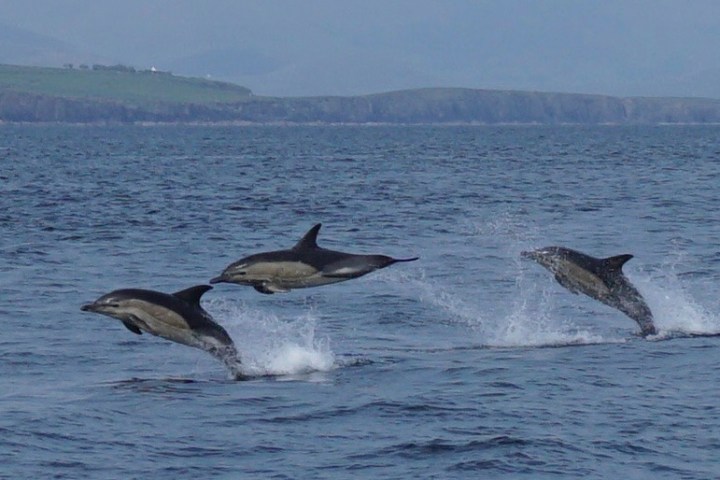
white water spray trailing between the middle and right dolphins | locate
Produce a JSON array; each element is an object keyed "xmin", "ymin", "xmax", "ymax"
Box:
[{"xmin": 380, "ymin": 212, "xmax": 626, "ymax": 347}]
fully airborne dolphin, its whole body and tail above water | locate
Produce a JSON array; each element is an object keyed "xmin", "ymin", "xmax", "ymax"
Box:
[{"xmin": 210, "ymin": 223, "xmax": 419, "ymax": 294}]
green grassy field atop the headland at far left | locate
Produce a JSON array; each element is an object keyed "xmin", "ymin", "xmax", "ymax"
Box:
[{"xmin": 0, "ymin": 65, "xmax": 251, "ymax": 104}]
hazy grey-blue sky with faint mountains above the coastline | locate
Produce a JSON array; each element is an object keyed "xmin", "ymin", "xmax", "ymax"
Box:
[{"xmin": 0, "ymin": 0, "xmax": 720, "ymax": 98}]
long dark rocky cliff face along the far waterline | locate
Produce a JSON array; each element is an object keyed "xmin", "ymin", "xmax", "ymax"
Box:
[{"xmin": 0, "ymin": 88, "xmax": 720, "ymax": 124}]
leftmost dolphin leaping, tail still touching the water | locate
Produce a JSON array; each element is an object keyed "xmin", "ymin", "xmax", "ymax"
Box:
[{"xmin": 80, "ymin": 285, "xmax": 243, "ymax": 379}]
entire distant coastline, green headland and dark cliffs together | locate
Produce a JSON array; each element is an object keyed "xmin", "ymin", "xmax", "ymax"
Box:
[{"xmin": 0, "ymin": 65, "xmax": 720, "ymax": 124}]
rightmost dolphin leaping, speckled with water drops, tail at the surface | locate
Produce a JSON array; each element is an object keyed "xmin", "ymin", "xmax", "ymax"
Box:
[{"xmin": 521, "ymin": 247, "xmax": 657, "ymax": 337}]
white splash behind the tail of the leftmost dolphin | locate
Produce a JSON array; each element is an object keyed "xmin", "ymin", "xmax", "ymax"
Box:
[{"xmin": 207, "ymin": 299, "xmax": 335, "ymax": 377}]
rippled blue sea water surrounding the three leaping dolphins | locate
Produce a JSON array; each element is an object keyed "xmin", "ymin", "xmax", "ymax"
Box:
[{"xmin": 0, "ymin": 125, "xmax": 720, "ymax": 479}]
